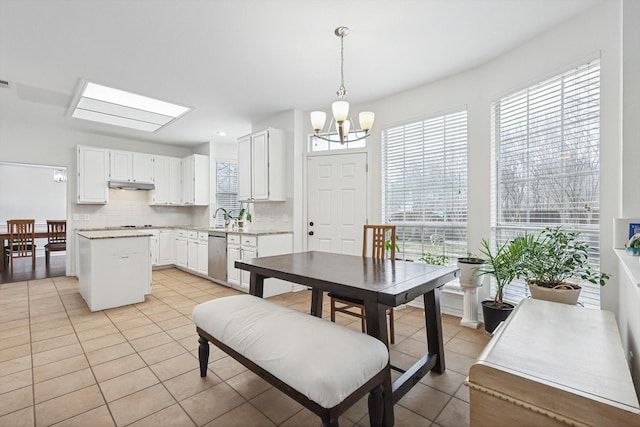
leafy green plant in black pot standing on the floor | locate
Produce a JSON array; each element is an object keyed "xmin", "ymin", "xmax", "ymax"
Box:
[{"xmin": 478, "ymin": 237, "xmax": 523, "ymax": 334}]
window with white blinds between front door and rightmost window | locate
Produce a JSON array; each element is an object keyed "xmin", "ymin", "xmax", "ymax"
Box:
[{"xmin": 382, "ymin": 111, "xmax": 467, "ymax": 263}]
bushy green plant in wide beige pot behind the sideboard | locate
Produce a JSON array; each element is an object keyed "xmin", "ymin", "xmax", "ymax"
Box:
[{"xmin": 521, "ymin": 227, "xmax": 609, "ymax": 304}]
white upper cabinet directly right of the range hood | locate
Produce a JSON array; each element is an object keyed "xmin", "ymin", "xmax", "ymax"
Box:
[{"xmin": 150, "ymin": 156, "xmax": 182, "ymax": 205}]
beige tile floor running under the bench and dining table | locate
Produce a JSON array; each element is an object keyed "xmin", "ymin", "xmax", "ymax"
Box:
[{"xmin": 0, "ymin": 269, "xmax": 488, "ymax": 427}]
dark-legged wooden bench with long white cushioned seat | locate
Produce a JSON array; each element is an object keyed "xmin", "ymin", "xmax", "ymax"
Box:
[{"xmin": 193, "ymin": 295, "xmax": 391, "ymax": 426}]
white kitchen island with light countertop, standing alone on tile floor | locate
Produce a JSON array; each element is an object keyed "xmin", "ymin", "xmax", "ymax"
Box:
[{"xmin": 77, "ymin": 230, "xmax": 152, "ymax": 311}]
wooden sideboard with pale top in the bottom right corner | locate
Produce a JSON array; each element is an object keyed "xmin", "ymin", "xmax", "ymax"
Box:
[{"xmin": 467, "ymin": 299, "xmax": 640, "ymax": 427}]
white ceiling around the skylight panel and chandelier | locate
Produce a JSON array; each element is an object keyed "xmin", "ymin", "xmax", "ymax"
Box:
[{"xmin": 0, "ymin": 0, "xmax": 600, "ymax": 146}]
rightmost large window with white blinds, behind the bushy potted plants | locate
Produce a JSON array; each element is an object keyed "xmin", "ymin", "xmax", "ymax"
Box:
[{"xmin": 492, "ymin": 61, "xmax": 600, "ymax": 307}]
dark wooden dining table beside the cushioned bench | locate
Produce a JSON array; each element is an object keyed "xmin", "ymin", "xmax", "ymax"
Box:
[{"xmin": 235, "ymin": 251, "xmax": 459, "ymax": 426}]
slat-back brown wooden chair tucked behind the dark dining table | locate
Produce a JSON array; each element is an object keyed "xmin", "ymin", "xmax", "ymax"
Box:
[{"xmin": 329, "ymin": 224, "xmax": 396, "ymax": 344}]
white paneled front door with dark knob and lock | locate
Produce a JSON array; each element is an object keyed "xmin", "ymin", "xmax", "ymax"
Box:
[{"xmin": 307, "ymin": 153, "xmax": 367, "ymax": 256}]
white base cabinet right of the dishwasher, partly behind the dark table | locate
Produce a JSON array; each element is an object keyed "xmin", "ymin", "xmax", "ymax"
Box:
[{"xmin": 227, "ymin": 233, "xmax": 293, "ymax": 297}]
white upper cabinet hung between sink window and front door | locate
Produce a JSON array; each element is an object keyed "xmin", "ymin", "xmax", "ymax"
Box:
[{"xmin": 238, "ymin": 128, "xmax": 286, "ymax": 202}]
